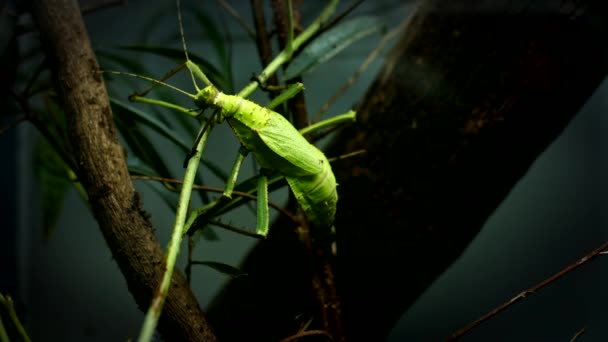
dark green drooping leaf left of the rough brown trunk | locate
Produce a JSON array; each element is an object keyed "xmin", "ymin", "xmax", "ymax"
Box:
[{"xmin": 32, "ymin": 137, "xmax": 72, "ymax": 239}]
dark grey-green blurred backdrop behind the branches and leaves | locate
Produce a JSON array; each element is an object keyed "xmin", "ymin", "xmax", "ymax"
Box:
[{"xmin": 0, "ymin": 1, "xmax": 608, "ymax": 341}]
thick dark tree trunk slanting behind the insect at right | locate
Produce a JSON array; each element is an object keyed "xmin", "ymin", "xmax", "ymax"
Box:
[{"xmin": 209, "ymin": 0, "xmax": 608, "ymax": 341}]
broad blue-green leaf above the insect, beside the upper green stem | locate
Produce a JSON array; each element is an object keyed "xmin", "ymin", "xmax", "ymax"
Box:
[{"xmin": 285, "ymin": 16, "xmax": 384, "ymax": 79}]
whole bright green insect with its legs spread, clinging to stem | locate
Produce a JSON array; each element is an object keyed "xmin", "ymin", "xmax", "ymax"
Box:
[{"xmin": 130, "ymin": 0, "xmax": 355, "ymax": 236}]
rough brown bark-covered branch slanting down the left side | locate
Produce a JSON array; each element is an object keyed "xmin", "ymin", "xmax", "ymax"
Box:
[{"xmin": 32, "ymin": 0, "xmax": 215, "ymax": 341}]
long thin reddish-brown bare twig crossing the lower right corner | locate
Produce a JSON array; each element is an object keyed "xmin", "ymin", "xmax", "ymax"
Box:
[{"xmin": 446, "ymin": 242, "xmax": 608, "ymax": 341}]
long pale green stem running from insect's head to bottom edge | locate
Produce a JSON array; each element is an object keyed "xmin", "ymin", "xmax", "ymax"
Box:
[{"xmin": 138, "ymin": 119, "xmax": 212, "ymax": 342}]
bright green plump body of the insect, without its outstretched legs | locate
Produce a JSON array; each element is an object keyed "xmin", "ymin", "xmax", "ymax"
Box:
[{"xmin": 192, "ymin": 68, "xmax": 338, "ymax": 227}]
